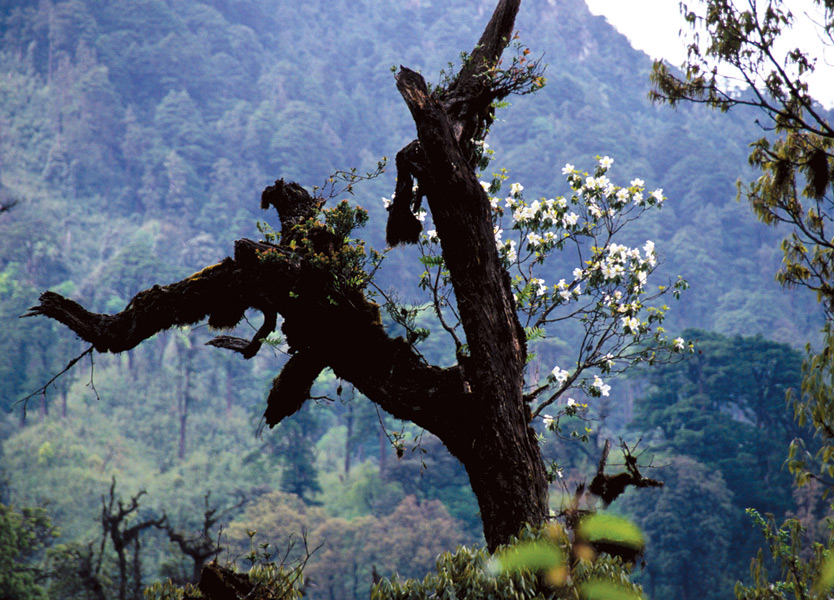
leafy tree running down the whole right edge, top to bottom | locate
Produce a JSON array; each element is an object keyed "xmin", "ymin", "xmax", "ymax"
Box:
[{"xmin": 651, "ymin": 0, "xmax": 834, "ymax": 598}]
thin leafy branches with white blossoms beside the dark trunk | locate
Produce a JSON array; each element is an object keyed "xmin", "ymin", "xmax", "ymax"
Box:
[{"xmin": 412, "ymin": 156, "xmax": 691, "ymax": 418}]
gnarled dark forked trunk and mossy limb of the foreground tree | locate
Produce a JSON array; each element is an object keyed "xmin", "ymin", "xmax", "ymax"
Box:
[{"xmin": 29, "ymin": 0, "xmax": 547, "ymax": 549}]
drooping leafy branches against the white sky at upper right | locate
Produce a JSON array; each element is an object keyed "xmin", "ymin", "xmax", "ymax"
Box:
[{"xmin": 650, "ymin": 0, "xmax": 834, "ymax": 324}]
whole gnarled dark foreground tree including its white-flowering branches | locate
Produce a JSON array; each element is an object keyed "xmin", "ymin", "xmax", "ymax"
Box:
[{"xmin": 30, "ymin": 0, "xmax": 686, "ymax": 549}]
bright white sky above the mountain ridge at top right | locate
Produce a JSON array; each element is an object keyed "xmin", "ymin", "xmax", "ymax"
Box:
[{"xmin": 585, "ymin": 0, "xmax": 834, "ymax": 108}]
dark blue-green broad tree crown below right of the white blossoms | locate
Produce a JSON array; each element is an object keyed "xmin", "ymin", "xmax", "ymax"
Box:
[{"xmin": 631, "ymin": 330, "xmax": 807, "ymax": 515}]
